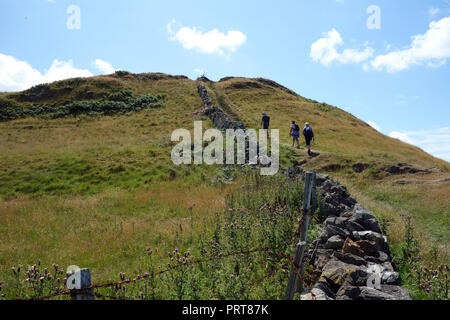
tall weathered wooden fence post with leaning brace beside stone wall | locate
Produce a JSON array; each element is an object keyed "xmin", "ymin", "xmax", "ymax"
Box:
[{"xmin": 284, "ymin": 172, "xmax": 315, "ymax": 300}]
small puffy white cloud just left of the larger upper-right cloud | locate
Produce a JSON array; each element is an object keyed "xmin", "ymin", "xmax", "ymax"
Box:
[{"xmin": 310, "ymin": 29, "xmax": 374, "ymax": 66}]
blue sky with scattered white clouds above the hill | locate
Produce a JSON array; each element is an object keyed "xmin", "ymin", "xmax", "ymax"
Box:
[{"xmin": 0, "ymin": 0, "xmax": 450, "ymax": 161}]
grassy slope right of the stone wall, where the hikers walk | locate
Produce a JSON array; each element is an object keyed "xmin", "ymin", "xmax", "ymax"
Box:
[{"xmin": 210, "ymin": 78, "xmax": 450, "ymax": 253}]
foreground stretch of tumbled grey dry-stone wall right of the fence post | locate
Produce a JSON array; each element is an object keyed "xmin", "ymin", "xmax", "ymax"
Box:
[{"xmin": 288, "ymin": 169, "xmax": 411, "ymax": 300}]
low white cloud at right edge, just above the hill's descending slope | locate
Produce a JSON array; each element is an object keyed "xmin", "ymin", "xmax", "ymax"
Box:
[{"xmin": 389, "ymin": 127, "xmax": 450, "ymax": 161}]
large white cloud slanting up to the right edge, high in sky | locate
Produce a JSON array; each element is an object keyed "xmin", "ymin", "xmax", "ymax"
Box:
[{"xmin": 364, "ymin": 17, "xmax": 450, "ymax": 73}]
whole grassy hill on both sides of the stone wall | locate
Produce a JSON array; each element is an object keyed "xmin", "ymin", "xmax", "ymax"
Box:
[{"xmin": 0, "ymin": 72, "xmax": 450, "ymax": 298}]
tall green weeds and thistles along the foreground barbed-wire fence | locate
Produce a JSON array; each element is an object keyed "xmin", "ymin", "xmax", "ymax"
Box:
[{"xmin": 2, "ymin": 172, "xmax": 310, "ymax": 299}]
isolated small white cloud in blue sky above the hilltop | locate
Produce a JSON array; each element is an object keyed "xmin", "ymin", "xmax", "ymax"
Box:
[{"xmin": 167, "ymin": 20, "xmax": 247, "ymax": 57}]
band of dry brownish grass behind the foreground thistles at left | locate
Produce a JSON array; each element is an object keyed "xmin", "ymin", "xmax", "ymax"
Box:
[{"xmin": 0, "ymin": 183, "xmax": 237, "ymax": 281}]
